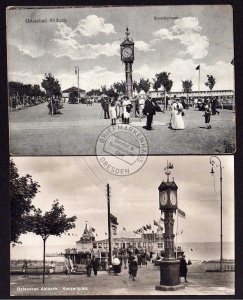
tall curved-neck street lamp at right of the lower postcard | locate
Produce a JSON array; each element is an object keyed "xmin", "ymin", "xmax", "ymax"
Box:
[{"xmin": 209, "ymin": 156, "xmax": 224, "ymax": 272}]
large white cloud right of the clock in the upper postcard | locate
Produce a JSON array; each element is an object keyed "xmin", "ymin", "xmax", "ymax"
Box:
[{"xmin": 153, "ymin": 17, "xmax": 209, "ymax": 59}]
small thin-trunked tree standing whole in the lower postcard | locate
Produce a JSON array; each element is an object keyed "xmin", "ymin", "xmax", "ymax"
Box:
[{"xmin": 29, "ymin": 200, "xmax": 77, "ymax": 283}]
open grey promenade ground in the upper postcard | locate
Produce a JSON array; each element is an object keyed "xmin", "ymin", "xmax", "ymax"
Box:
[{"xmin": 9, "ymin": 103, "xmax": 235, "ymax": 155}]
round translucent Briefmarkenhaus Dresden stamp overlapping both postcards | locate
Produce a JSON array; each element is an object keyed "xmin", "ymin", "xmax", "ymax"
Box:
[{"xmin": 96, "ymin": 124, "xmax": 148, "ymax": 176}]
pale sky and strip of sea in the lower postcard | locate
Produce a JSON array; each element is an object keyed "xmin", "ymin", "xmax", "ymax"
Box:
[{"xmin": 10, "ymin": 156, "xmax": 234, "ymax": 253}]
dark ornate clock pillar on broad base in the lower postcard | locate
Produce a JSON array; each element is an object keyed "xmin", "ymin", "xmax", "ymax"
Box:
[{"xmin": 155, "ymin": 162, "xmax": 185, "ymax": 291}]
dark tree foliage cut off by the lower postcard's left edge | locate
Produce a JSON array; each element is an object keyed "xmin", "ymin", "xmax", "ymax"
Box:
[{"xmin": 9, "ymin": 160, "xmax": 40, "ymax": 246}]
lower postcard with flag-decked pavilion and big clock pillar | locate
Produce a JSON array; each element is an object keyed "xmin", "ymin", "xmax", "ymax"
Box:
[{"xmin": 10, "ymin": 155, "xmax": 235, "ymax": 297}]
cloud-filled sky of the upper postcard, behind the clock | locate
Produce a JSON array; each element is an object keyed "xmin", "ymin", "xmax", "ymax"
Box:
[{"xmin": 7, "ymin": 5, "xmax": 234, "ymax": 92}]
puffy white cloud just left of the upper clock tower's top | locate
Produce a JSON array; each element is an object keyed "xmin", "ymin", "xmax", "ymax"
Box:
[{"xmin": 75, "ymin": 15, "xmax": 116, "ymax": 37}]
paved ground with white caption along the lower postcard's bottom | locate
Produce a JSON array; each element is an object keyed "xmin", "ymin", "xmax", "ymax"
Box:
[{"xmin": 11, "ymin": 262, "xmax": 234, "ymax": 296}]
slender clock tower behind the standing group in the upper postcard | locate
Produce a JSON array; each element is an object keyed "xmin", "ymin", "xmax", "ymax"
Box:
[{"xmin": 120, "ymin": 28, "xmax": 134, "ymax": 100}]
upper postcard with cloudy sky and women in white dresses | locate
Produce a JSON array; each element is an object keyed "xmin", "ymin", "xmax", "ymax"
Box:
[{"xmin": 6, "ymin": 5, "xmax": 237, "ymax": 156}]
